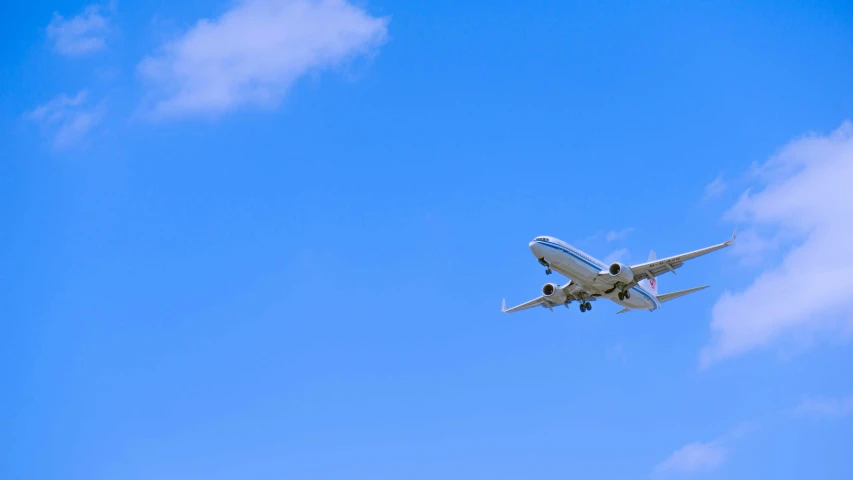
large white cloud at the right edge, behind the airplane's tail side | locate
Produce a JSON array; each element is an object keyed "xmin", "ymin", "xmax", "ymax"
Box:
[{"xmin": 700, "ymin": 122, "xmax": 853, "ymax": 366}]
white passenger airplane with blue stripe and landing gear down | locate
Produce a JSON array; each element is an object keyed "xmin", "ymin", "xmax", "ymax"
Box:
[{"xmin": 501, "ymin": 229, "xmax": 737, "ymax": 313}]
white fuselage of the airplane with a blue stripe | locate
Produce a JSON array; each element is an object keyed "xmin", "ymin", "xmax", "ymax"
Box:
[{"xmin": 530, "ymin": 237, "xmax": 660, "ymax": 311}]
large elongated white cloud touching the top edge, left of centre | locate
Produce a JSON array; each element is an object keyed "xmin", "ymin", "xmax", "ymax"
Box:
[{"xmin": 139, "ymin": 0, "xmax": 389, "ymax": 116}]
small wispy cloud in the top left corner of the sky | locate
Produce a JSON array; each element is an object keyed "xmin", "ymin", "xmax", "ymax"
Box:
[{"xmin": 47, "ymin": 5, "xmax": 109, "ymax": 56}]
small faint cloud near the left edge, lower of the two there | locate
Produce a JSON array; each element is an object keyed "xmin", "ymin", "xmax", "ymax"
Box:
[{"xmin": 25, "ymin": 90, "xmax": 102, "ymax": 149}]
